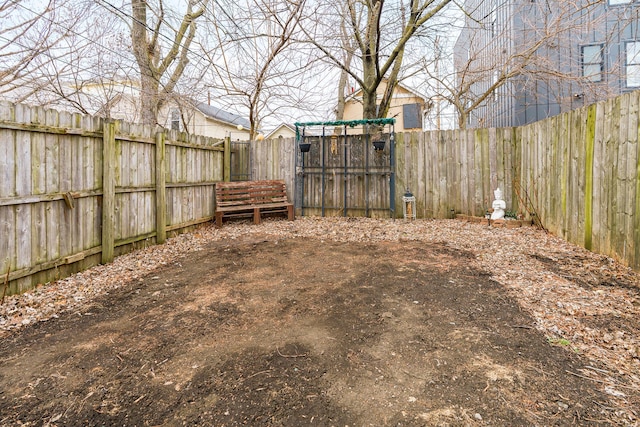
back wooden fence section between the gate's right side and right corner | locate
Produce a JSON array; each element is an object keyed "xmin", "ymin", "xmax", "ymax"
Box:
[{"xmin": 396, "ymin": 128, "xmax": 518, "ymax": 218}]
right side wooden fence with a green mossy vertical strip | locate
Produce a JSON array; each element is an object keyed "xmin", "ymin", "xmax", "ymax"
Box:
[{"xmin": 520, "ymin": 92, "xmax": 640, "ymax": 269}]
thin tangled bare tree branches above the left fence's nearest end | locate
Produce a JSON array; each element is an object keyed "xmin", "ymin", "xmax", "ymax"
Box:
[{"xmin": 0, "ymin": 0, "xmax": 146, "ymax": 120}]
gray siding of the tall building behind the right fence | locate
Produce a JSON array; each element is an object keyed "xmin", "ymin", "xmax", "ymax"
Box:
[{"xmin": 454, "ymin": 0, "xmax": 640, "ymax": 128}]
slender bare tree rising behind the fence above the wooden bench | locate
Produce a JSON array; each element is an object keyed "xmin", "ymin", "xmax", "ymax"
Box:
[{"xmin": 203, "ymin": 0, "xmax": 313, "ymax": 139}]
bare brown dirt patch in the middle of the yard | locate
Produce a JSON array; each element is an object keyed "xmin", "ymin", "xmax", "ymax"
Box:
[{"xmin": 0, "ymin": 222, "xmax": 640, "ymax": 427}]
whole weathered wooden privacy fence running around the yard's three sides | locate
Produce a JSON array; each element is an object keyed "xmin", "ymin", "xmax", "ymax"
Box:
[{"xmin": 0, "ymin": 88, "xmax": 640, "ymax": 293}]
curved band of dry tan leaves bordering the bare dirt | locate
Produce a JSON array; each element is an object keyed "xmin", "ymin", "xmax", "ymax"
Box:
[{"xmin": 0, "ymin": 217, "xmax": 640, "ymax": 422}]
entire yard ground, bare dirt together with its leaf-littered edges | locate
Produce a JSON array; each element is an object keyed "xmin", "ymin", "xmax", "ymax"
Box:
[{"xmin": 0, "ymin": 218, "xmax": 640, "ymax": 427}]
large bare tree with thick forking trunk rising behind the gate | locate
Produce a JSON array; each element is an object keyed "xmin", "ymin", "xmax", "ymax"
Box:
[{"xmin": 305, "ymin": 0, "xmax": 451, "ymax": 118}]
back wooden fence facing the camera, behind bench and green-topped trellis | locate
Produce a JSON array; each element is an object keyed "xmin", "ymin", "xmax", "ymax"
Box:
[{"xmin": 251, "ymin": 128, "xmax": 520, "ymax": 218}]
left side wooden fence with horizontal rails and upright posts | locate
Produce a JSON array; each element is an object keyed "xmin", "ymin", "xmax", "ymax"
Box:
[{"xmin": 0, "ymin": 103, "xmax": 231, "ymax": 293}]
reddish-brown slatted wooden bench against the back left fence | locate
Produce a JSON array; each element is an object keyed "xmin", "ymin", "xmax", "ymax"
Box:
[{"xmin": 215, "ymin": 180, "xmax": 294, "ymax": 227}]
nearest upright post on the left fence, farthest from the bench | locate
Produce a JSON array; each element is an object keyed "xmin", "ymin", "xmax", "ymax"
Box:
[{"xmin": 102, "ymin": 120, "xmax": 116, "ymax": 264}]
